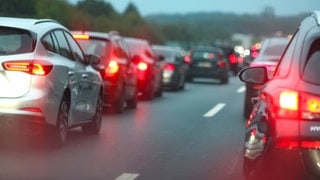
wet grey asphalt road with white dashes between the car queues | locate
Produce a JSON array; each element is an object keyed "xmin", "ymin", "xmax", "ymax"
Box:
[{"xmin": 0, "ymin": 77, "xmax": 249, "ymax": 180}]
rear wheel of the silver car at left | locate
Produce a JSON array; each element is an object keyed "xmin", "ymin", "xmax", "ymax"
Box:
[{"xmin": 53, "ymin": 95, "xmax": 70, "ymax": 148}]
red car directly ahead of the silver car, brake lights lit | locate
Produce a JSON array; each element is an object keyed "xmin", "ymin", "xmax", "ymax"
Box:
[{"xmin": 72, "ymin": 31, "xmax": 138, "ymax": 113}]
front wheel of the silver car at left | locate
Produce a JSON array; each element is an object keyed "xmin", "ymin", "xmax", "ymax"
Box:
[{"xmin": 81, "ymin": 93, "xmax": 103, "ymax": 134}]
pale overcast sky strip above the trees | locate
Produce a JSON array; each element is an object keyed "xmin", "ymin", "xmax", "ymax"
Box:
[{"xmin": 69, "ymin": 0, "xmax": 320, "ymax": 16}]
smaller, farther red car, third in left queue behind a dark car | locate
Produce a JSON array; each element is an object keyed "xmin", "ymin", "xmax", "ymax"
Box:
[{"xmin": 125, "ymin": 37, "xmax": 163, "ymax": 100}]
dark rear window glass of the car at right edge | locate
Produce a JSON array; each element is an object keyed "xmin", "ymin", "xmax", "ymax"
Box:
[{"xmin": 302, "ymin": 39, "xmax": 320, "ymax": 84}]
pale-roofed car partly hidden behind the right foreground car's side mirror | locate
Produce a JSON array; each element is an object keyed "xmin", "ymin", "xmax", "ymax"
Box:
[{"xmin": 243, "ymin": 37, "xmax": 290, "ymax": 118}]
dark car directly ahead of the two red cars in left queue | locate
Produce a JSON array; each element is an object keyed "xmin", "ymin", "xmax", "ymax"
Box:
[{"xmin": 152, "ymin": 45, "xmax": 188, "ymax": 90}]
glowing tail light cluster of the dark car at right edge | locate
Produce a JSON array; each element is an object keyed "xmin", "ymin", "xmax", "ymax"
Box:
[{"xmin": 274, "ymin": 90, "xmax": 320, "ymax": 120}]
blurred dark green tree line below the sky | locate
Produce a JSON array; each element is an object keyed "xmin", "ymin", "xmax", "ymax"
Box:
[{"xmin": 0, "ymin": 0, "xmax": 306, "ymax": 47}]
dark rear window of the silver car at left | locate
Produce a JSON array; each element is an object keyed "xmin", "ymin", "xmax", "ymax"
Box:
[{"xmin": 0, "ymin": 27, "xmax": 33, "ymax": 55}]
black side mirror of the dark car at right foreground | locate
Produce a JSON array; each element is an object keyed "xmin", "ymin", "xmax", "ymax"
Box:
[{"xmin": 239, "ymin": 67, "xmax": 269, "ymax": 85}]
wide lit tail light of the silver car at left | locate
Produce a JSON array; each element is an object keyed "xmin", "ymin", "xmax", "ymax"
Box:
[{"xmin": 2, "ymin": 60, "xmax": 53, "ymax": 76}]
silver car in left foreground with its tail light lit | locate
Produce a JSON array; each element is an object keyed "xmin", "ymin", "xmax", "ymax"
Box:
[{"xmin": 0, "ymin": 17, "xmax": 103, "ymax": 147}]
